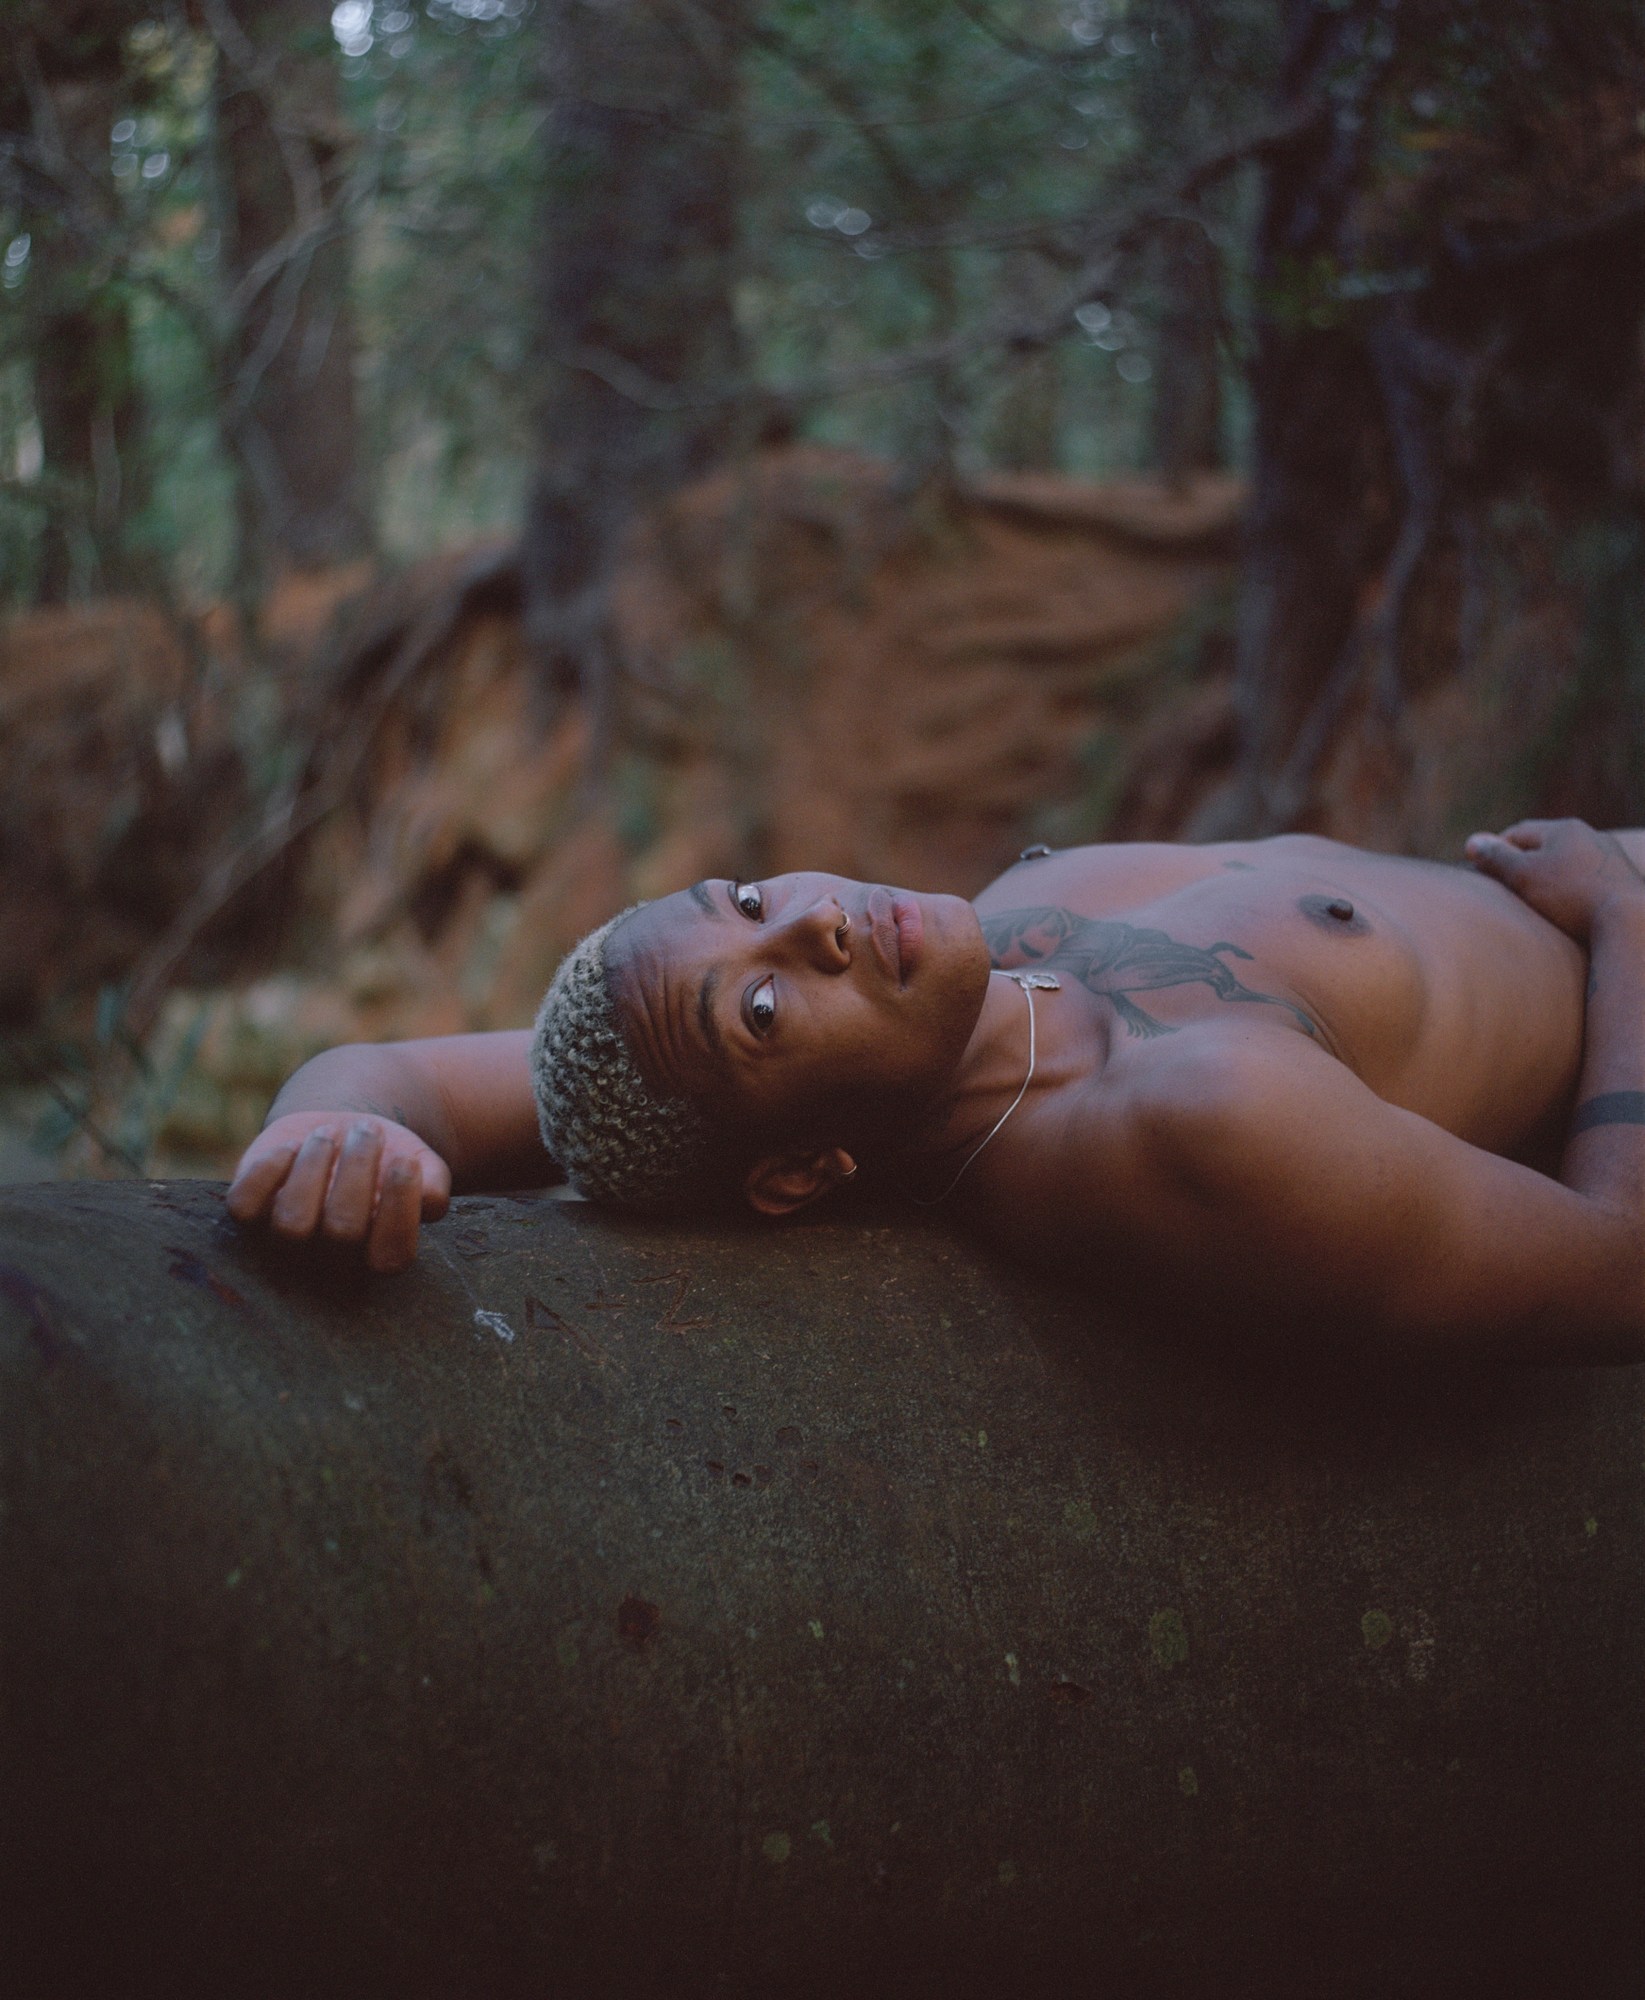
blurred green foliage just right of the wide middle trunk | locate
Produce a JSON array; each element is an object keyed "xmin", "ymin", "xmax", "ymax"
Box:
[{"xmin": 742, "ymin": 0, "xmax": 1273, "ymax": 472}]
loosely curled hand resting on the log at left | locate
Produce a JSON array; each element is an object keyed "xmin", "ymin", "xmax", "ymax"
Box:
[{"xmin": 228, "ymin": 1112, "xmax": 450, "ymax": 1270}]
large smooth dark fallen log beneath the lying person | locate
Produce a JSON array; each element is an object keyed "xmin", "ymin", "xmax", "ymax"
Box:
[{"xmin": 0, "ymin": 1184, "xmax": 1645, "ymax": 2000}]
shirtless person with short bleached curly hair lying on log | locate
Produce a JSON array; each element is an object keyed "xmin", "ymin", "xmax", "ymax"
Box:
[{"xmin": 228, "ymin": 820, "xmax": 1645, "ymax": 1362}]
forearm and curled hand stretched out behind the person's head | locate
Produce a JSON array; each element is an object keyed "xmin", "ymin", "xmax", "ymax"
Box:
[{"xmin": 228, "ymin": 1030, "xmax": 558, "ymax": 1270}]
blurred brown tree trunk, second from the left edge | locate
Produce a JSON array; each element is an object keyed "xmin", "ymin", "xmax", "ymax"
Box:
[{"xmin": 202, "ymin": 0, "xmax": 370, "ymax": 568}]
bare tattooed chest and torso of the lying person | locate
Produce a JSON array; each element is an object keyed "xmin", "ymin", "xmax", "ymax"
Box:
[{"xmin": 977, "ymin": 836, "xmax": 1583, "ymax": 1150}]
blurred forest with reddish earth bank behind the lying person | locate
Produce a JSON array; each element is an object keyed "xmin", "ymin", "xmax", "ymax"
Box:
[{"xmin": 0, "ymin": 0, "xmax": 1645, "ymax": 1178}]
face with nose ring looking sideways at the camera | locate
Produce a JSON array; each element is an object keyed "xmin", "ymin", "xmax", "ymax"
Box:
[{"xmin": 606, "ymin": 874, "xmax": 989, "ymax": 1142}]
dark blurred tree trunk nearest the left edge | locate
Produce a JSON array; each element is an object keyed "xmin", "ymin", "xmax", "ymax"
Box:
[{"xmin": 4, "ymin": 4, "xmax": 146, "ymax": 604}]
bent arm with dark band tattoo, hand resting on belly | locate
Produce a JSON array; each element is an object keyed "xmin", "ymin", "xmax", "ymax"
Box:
[{"xmin": 996, "ymin": 826, "xmax": 1645, "ymax": 1362}]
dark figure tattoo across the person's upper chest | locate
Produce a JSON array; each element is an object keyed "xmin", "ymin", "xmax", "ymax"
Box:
[{"xmin": 983, "ymin": 904, "xmax": 1319, "ymax": 1038}]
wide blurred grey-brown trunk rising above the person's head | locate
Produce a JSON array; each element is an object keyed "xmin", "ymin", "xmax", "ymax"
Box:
[{"xmin": 524, "ymin": 0, "xmax": 744, "ymax": 740}]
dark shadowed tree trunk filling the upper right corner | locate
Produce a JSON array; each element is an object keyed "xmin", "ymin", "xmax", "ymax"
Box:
[{"xmin": 1232, "ymin": 0, "xmax": 1645, "ymax": 838}]
